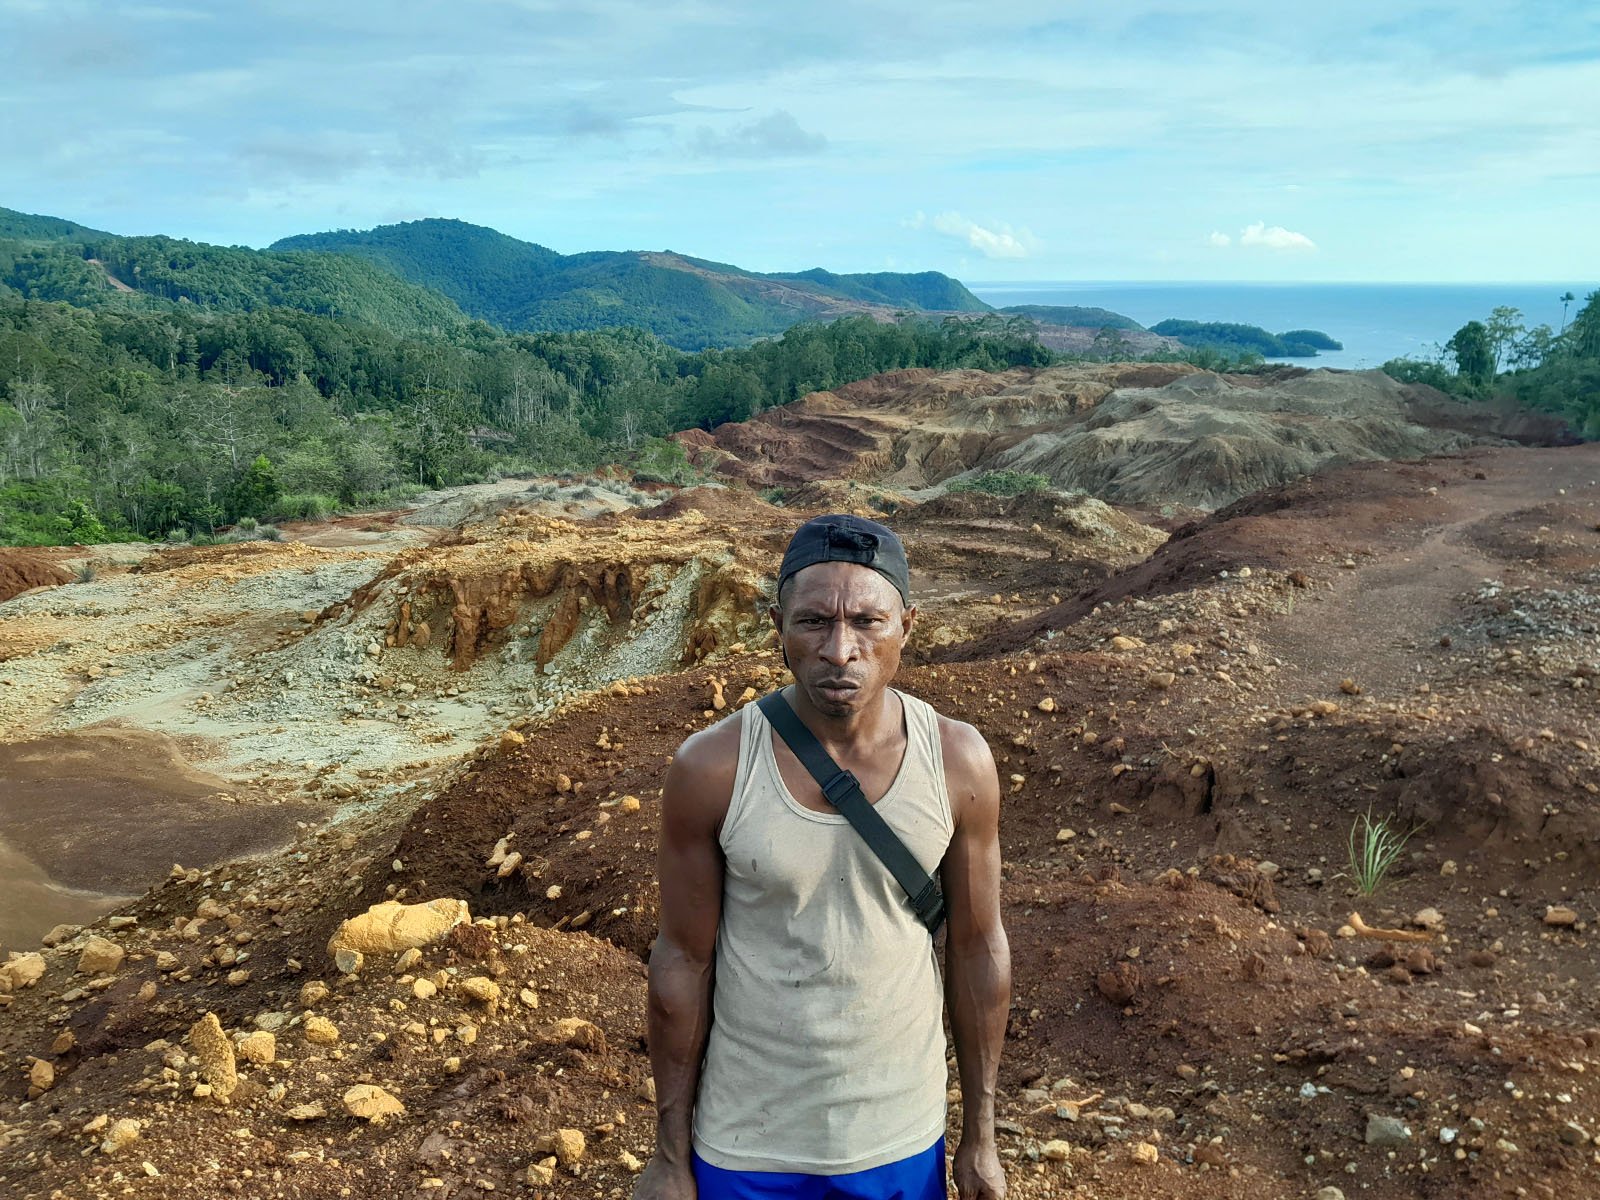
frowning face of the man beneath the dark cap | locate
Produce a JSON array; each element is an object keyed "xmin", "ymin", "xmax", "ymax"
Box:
[{"xmin": 771, "ymin": 563, "xmax": 917, "ymax": 717}]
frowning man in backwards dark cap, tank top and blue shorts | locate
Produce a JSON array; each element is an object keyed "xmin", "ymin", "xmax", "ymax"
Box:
[{"xmin": 634, "ymin": 515, "xmax": 1011, "ymax": 1200}]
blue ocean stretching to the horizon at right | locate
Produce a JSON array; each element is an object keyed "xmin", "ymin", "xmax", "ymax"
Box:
[{"xmin": 966, "ymin": 282, "xmax": 1600, "ymax": 370}]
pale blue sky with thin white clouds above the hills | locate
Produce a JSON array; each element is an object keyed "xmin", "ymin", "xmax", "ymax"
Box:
[{"xmin": 0, "ymin": 0, "xmax": 1600, "ymax": 282}]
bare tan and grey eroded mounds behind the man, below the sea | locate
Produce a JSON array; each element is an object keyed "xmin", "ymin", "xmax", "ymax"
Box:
[{"xmin": 677, "ymin": 363, "xmax": 1497, "ymax": 509}]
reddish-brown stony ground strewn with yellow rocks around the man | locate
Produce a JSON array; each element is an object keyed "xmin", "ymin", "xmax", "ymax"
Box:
[{"xmin": 0, "ymin": 435, "xmax": 1600, "ymax": 1200}]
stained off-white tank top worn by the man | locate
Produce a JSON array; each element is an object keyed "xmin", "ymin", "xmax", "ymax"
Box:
[{"xmin": 694, "ymin": 693, "xmax": 954, "ymax": 1174}]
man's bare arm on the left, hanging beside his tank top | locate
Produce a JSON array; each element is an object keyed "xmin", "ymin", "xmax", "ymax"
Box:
[{"xmin": 634, "ymin": 722, "xmax": 739, "ymax": 1200}]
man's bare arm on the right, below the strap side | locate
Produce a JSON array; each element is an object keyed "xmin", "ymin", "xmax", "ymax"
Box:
[{"xmin": 941, "ymin": 720, "xmax": 1011, "ymax": 1200}]
